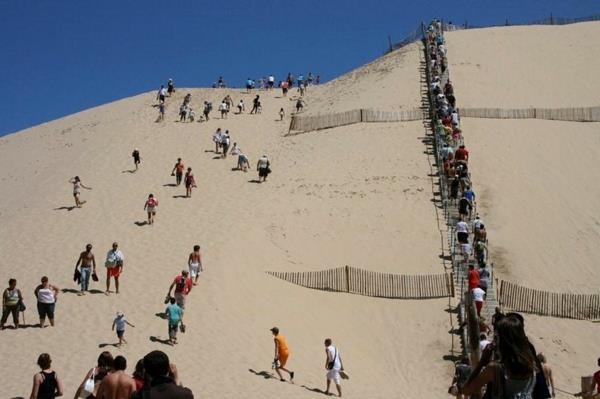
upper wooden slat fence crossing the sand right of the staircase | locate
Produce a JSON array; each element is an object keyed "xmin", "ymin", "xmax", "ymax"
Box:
[{"xmin": 459, "ymin": 107, "xmax": 600, "ymax": 122}]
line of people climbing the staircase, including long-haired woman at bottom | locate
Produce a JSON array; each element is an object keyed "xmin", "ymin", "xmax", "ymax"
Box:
[{"xmin": 425, "ymin": 20, "xmax": 600, "ymax": 399}]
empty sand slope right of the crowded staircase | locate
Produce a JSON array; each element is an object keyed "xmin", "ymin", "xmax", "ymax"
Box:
[{"xmin": 446, "ymin": 22, "xmax": 600, "ymax": 392}]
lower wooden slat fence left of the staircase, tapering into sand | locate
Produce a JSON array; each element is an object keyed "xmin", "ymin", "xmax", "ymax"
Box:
[{"xmin": 267, "ymin": 266, "xmax": 454, "ymax": 299}]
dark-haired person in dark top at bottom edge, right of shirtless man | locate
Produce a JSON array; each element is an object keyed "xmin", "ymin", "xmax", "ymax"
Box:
[{"xmin": 132, "ymin": 351, "xmax": 194, "ymax": 399}]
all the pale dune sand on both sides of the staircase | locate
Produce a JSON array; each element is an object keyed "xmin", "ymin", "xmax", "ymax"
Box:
[{"xmin": 0, "ymin": 19, "xmax": 600, "ymax": 398}]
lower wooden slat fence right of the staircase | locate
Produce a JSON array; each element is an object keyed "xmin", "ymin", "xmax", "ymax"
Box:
[{"xmin": 499, "ymin": 281, "xmax": 600, "ymax": 320}]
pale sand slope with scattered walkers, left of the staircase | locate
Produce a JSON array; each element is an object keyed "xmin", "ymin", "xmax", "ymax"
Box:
[{"xmin": 0, "ymin": 40, "xmax": 452, "ymax": 398}]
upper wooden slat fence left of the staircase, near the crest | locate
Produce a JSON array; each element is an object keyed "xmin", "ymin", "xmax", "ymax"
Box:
[{"xmin": 286, "ymin": 108, "xmax": 423, "ymax": 136}]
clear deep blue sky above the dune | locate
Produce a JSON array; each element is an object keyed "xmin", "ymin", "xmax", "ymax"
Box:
[{"xmin": 0, "ymin": 0, "xmax": 600, "ymax": 136}]
